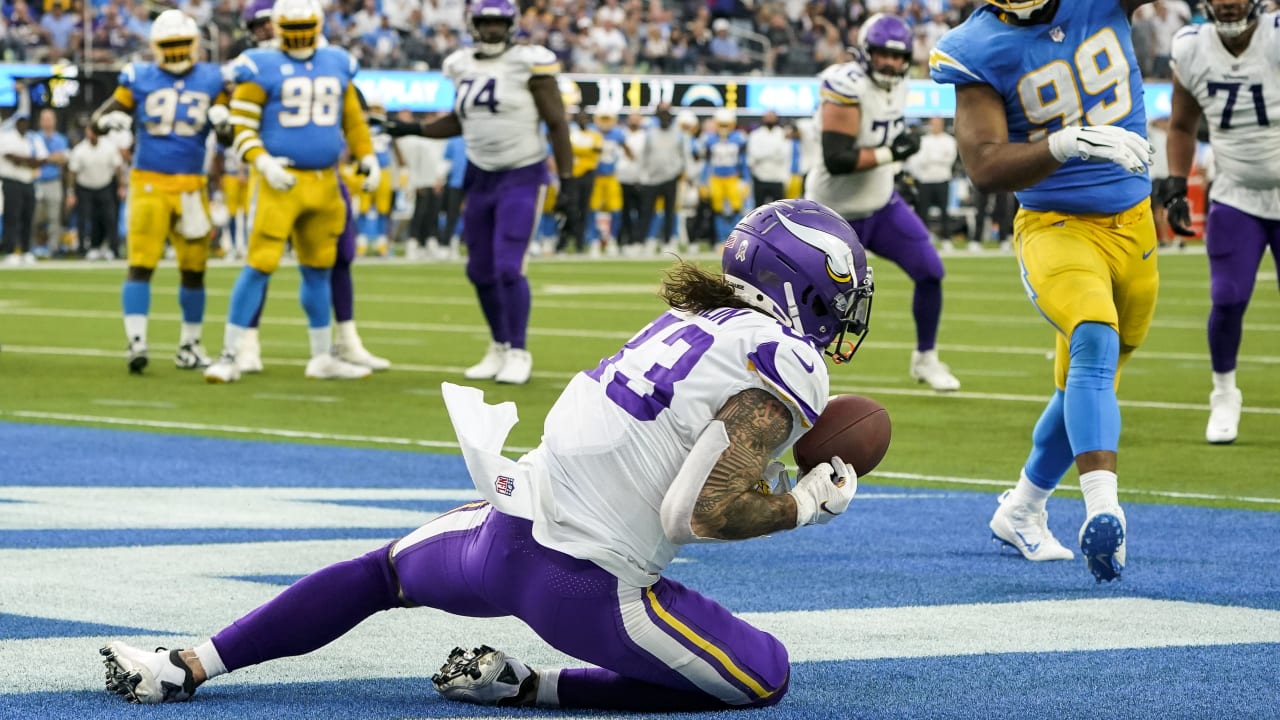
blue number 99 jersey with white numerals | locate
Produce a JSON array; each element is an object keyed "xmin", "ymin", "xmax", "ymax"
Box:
[{"xmin": 929, "ymin": 0, "xmax": 1151, "ymax": 214}]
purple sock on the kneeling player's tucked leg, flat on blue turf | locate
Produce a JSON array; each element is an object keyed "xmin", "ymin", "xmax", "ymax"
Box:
[{"xmin": 556, "ymin": 667, "xmax": 790, "ymax": 712}]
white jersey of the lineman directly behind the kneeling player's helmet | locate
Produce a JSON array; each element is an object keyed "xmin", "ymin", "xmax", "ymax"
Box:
[{"xmin": 804, "ymin": 63, "xmax": 906, "ymax": 219}]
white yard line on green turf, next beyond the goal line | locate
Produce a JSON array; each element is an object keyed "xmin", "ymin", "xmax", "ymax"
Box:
[{"xmin": 4, "ymin": 343, "xmax": 1280, "ymax": 415}]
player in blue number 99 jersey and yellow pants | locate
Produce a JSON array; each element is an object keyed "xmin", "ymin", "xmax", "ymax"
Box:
[{"xmin": 929, "ymin": 0, "xmax": 1160, "ymax": 582}]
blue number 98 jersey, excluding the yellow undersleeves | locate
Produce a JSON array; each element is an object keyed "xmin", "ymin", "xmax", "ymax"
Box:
[{"xmin": 232, "ymin": 46, "xmax": 360, "ymax": 170}]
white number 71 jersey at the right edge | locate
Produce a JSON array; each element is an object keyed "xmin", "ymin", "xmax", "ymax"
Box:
[{"xmin": 1172, "ymin": 13, "xmax": 1280, "ymax": 219}]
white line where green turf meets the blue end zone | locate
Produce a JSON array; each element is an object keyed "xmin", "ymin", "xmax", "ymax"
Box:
[{"xmin": 0, "ymin": 410, "xmax": 1280, "ymax": 505}]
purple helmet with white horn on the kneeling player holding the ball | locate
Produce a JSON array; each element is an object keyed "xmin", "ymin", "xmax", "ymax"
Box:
[{"xmin": 721, "ymin": 200, "xmax": 874, "ymax": 363}]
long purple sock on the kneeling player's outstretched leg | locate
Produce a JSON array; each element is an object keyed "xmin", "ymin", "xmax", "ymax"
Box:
[{"xmin": 212, "ymin": 546, "xmax": 401, "ymax": 671}]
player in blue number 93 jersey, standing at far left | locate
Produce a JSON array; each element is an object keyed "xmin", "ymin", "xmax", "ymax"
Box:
[{"xmin": 93, "ymin": 10, "xmax": 228, "ymax": 373}]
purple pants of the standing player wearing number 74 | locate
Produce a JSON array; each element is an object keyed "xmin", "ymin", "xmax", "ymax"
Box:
[{"xmin": 462, "ymin": 163, "xmax": 549, "ymax": 348}]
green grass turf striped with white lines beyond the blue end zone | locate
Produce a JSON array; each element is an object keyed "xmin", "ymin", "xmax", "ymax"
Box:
[{"xmin": 0, "ymin": 252, "xmax": 1280, "ymax": 510}]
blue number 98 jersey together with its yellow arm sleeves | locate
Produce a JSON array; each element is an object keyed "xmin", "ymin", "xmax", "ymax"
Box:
[{"xmin": 229, "ymin": 46, "xmax": 371, "ymax": 170}]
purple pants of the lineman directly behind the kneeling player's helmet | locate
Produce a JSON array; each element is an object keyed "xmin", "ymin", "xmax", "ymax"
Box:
[{"xmin": 849, "ymin": 191, "xmax": 946, "ymax": 352}]
